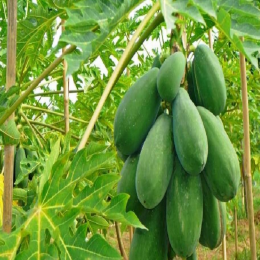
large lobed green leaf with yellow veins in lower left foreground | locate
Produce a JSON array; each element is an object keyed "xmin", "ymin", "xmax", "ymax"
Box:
[{"xmin": 0, "ymin": 143, "xmax": 144, "ymax": 260}]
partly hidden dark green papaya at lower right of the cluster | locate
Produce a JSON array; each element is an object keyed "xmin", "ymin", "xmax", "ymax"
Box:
[{"xmin": 200, "ymin": 174, "xmax": 226, "ymax": 250}]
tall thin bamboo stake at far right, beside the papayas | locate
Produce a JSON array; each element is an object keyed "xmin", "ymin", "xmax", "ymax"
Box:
[{"xmin": 240, "ymin": 38, "xmax": 256, "ymax": 260}]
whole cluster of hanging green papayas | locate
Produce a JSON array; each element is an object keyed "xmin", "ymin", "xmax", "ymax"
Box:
[{"xmin": 114, "ymin": 45, "xmax": 240, "ymax": 260}]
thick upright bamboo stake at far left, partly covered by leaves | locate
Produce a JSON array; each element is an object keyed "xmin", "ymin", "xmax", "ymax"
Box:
[{"xmin": 2, "ymin": 0, "xmax": 17, "ymax": 233}]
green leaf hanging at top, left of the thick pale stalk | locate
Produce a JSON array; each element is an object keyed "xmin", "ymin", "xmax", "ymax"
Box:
[{"xmin": 60, "ymin": 0, "xmax": 146, "ymax": 75}]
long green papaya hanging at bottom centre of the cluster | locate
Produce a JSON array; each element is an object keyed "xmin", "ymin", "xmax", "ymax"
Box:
[{"xmin": 166, "ymin": 160, "xmax": 203, "ymax": 257}]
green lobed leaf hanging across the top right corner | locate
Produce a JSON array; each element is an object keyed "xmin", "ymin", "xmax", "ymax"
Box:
[{"xmin": 160, "ymin": 0, "xmax": 260, "ymax": 67}]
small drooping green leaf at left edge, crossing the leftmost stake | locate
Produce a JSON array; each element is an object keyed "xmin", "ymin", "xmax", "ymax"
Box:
[{"xmin": 0, "ymin": 120, "xmax": 20, "ymax": 145}]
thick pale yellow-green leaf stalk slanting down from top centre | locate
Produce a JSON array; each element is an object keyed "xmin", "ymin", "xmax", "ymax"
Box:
[{"xmin": 78, "ymin": 2, "xmax": 163, "ymax": 150}]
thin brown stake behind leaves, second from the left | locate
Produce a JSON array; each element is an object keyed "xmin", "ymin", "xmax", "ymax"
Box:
[{"xmin": 61, "ymin": 20, "xmax": 70, "ymax": 134}]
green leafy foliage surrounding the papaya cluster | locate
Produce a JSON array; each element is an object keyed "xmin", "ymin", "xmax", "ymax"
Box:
[{"xmin": 0, "ymin": 0, "xmax": 260, "ymax": 260}]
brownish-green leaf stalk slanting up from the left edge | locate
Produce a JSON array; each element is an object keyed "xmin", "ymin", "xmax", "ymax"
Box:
[{"xmin": 0, "ymin": 45, "xmax": 76, "ymax": 125}]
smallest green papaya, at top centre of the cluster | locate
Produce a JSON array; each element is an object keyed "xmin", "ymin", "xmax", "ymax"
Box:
[{"xmin": 157, "ymin": 52, "xmax": 186, "ymax": 102}]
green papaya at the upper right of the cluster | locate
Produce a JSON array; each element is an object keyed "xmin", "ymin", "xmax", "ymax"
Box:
[{"xmin": 192, "ymin": 45, "xmax": 227, "ymax": 115}]
